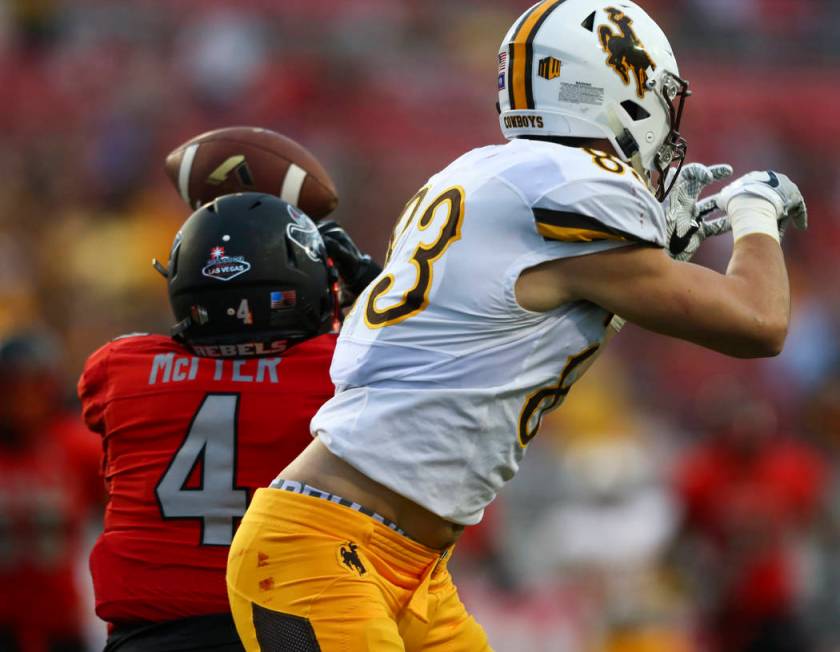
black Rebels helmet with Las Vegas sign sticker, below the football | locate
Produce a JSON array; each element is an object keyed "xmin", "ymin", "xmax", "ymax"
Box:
[{"xmin": 162, "ymin": 193, "xmax": 337, "ymax": 357}]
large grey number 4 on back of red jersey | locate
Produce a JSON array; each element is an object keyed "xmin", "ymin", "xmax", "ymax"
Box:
[{"xmin": 155, "ymin": 394, "xmax": 248, "ymax": 546}]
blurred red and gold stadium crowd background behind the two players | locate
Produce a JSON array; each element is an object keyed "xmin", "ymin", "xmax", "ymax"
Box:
[{"xmin": 0, "ymin": 0, "xmax": 840, "ymax": 652}]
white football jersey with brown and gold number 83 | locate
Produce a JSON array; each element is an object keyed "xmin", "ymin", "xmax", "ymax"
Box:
[{"xmin": 312, "ymin": 140, "xmax": 665, "ymax": 525}]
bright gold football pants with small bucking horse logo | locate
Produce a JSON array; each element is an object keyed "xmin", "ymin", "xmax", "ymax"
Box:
[{"xmin": 227, "ymin": 489, "xmax": 491, "ymax": 652}]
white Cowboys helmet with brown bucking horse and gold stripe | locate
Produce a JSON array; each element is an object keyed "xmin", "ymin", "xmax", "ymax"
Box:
[{"xmin": 498, "ymin": 0, "xmax": 690, "ymax": 199}]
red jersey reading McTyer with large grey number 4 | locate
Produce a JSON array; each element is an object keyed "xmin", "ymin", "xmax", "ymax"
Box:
[{"xmin": 79, "ymin": 335, "xmax": 336, "ymax": 623}]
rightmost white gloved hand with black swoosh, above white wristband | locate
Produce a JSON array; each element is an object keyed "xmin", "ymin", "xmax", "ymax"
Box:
[{"xmin": 710, "ymin": 170, "xmax": 808, "ymax": 236}]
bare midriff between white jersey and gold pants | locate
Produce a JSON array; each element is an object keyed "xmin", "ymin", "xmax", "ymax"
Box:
[{"xmin": 280, "ymin": 439, "xmax": 464, "ymax": 550}]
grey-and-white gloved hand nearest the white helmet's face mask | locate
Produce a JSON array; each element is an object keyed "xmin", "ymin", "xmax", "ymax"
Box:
[{"xmin": 665, "ymin": 163, "xmax": 732, "ymax": 261}]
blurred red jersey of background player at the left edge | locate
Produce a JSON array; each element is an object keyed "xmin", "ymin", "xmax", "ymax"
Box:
[{"xmin": 0, "ymin": 415, "xmax": 103, "ymax": 636}]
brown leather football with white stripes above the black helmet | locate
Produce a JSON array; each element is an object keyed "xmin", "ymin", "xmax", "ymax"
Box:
[{"xmin": 166, "ymin": 127, "xmax": 338, "ymax": 220}]
